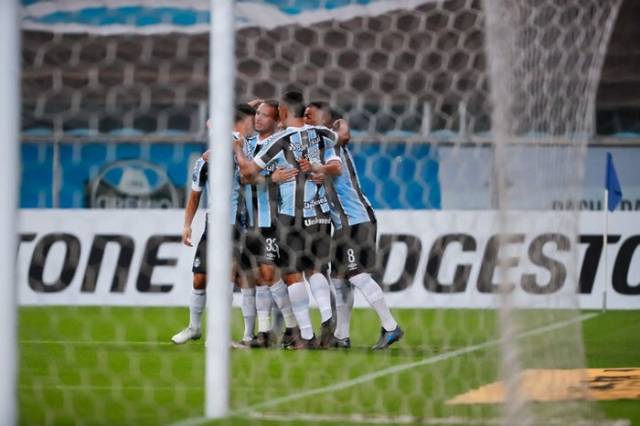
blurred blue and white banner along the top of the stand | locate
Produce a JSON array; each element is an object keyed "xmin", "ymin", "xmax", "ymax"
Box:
[{"xmin": 22, "ymin": 0, "xmax": 436, "ymax": 34}]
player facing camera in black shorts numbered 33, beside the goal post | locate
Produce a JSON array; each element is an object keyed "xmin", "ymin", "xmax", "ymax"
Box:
[{"xmin": 239, "ymin": 100, "xmax": 299, "ymax": 348}]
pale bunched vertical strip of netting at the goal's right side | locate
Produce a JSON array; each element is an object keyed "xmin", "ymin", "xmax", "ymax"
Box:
[{"xmin": 486, "ymin": 1, "xmax": 620, "ymax": 424}]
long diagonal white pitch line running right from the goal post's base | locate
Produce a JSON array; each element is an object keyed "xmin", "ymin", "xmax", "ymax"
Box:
[{"xmin": 171, "ymin": 313, "xmax": 599, "ymax": 426}]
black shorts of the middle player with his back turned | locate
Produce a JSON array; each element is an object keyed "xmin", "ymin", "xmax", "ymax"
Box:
[{"xmin": 277, "ymin": 215, "xmax": 331, "ymax": 274}]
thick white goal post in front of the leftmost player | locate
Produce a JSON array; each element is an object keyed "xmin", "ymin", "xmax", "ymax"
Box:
[{"xmin": 205, "ymin": 0, "xmax": 235, "ymax": 418}]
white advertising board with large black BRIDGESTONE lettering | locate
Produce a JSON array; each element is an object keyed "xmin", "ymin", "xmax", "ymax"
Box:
[{"xmin": 17, "ymin": 209, "xmax": 640, "ymax": 309}]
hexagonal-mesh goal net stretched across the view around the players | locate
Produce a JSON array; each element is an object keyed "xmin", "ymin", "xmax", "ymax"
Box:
[{"xmin": 17, "ymin": 0, "xmax": 621, "ymax": 425}]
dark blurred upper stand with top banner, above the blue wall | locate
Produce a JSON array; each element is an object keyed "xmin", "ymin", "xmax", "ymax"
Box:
[{"xmin": 22, "ymin": 0, "xmax": 640, "ymax": 140}]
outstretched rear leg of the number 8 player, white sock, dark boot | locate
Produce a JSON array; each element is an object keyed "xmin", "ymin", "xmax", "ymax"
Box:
[{"xmin": 345, "ymin": 223, "xmax": 404, "ymax": 350}]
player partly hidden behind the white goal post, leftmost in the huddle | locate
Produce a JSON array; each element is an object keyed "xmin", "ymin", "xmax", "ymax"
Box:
[{"xmin": 171, "ymin": 104, "xmax": 255, "ymax": 345}]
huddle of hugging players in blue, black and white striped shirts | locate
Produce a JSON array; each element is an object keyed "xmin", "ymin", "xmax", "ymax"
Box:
[{"xmin": 171, "ymin": 91, "xmax": 404, "ymax": 350}]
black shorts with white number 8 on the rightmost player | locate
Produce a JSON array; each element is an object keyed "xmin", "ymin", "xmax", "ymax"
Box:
[{"xmin": 331, "ymin": 222, "xmax": 377, "ymax": 278}]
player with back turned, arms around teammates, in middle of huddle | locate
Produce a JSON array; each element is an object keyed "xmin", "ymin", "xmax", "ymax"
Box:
[{"xmin": 234, "ymin": 92, "xmax": 342, "ymax": 349}]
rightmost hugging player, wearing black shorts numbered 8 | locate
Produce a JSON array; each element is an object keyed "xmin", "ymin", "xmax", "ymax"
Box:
[{"xmin": 305, "ymin": 102, "xmax": 404, "ymax": 350}]
